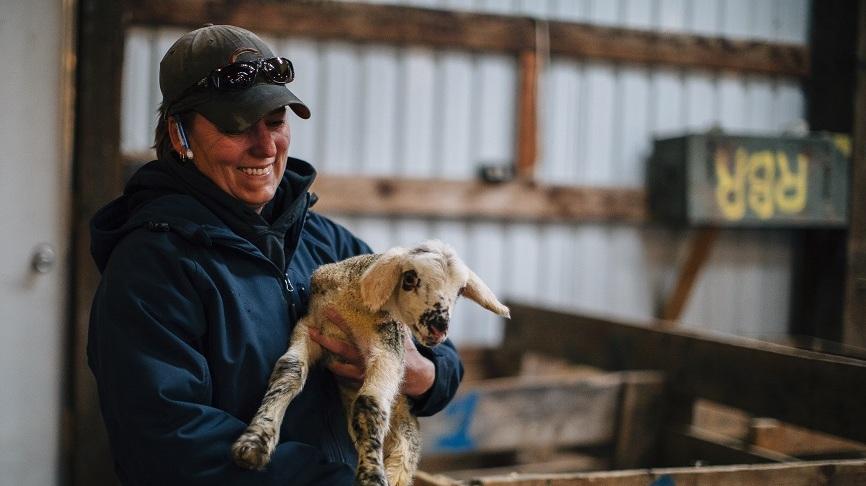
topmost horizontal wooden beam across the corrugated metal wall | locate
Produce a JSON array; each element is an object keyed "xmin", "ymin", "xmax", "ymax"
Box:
[{"xmin": 128, "ymin": 0, "xmax": 809, "ymax": 77}]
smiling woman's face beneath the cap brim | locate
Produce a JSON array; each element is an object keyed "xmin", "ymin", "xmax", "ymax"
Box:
[{"xmin": 184, "ymin": 107, "xmax": 291, "ymax": 212}]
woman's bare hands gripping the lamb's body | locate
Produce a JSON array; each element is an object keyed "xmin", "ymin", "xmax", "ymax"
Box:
[{"xmin": 309, "ymin": 309, "xmax": 436, "ymax": 398}]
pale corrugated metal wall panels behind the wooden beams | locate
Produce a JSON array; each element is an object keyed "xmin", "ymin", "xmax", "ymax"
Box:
[{"xmin": 122, "ymin": 0, "xmax": 809, "ymax": 345}]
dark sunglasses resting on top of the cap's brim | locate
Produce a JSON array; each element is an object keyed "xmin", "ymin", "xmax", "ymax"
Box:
[{"xmin": 193, "ymin": 57, "xmax": 295, "ymax": 91}]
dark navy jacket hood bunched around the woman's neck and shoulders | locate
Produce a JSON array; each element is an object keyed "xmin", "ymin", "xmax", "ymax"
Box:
[{"xmin": 90, "ymin": 157, "xmax": 316, "ymax": 272}]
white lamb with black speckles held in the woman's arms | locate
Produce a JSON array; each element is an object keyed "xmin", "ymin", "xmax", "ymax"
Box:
[{"xmin": 232, "ymin": 240, "xmax": 509, "ymax": 486}]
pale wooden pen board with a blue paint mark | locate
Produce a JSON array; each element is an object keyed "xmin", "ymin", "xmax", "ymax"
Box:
[{"xmin": 421, "ymin": 373, "xmax": 636, "ymax": 455}]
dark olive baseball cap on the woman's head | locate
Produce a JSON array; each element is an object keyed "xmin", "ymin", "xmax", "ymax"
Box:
[{"xmin": 159, "ymin": 25, "xmax": 310, "ymax": 133}]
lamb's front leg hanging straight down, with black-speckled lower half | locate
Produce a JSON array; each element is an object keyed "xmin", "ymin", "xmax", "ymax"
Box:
[{"xmin": 349, "ymin": 322, "xmax": 405, "ymax": 486}]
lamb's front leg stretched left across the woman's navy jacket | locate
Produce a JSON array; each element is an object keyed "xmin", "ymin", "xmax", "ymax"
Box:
[{"xmin": 232, "ymin": 319, "xmax": 321, "ymax": 469}]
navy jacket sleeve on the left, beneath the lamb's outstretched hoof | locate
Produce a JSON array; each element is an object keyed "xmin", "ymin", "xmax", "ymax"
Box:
[{"xmin": 88, "ymin": 234, "xmax": 353, "ymax": 486}]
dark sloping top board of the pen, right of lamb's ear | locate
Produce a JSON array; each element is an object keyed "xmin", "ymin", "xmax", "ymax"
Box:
[{"xmin": 503, "ymin": 303, "xmax": 866, "ymax": 442}]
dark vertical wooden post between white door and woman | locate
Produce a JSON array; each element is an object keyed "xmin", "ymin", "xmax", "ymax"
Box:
[{"xmin": 67, "ymin": 0, "xmax": 124, "ymax": 486}]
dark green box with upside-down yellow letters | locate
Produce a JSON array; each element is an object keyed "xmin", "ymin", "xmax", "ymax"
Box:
[{"xmin": 647, "ymin": 132, "xmax": 848, "ymax": 227}]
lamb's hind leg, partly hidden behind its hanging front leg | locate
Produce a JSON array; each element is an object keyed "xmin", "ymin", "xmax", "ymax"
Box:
[{"xmin": 385, "ymin": 397, "xmax": 421, "ymax": 486}]
